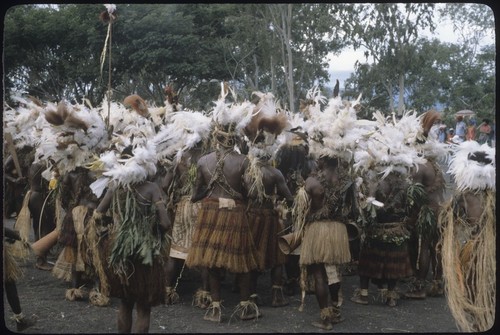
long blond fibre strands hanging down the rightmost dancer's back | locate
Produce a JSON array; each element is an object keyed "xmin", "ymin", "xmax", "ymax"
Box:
[{"xmin": 439, "ymin": 190, "xmax": 497, "ymax": 332}]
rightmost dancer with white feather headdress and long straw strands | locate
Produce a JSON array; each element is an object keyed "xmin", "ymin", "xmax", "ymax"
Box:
[{"xmin": 439, "ymin": 141, "xmax": 497, "ymax": 332}]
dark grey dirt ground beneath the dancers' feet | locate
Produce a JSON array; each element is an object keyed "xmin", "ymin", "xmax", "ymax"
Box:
[{"xmin": 2, "ymin": 219, "xmax": 458, "ymax": 334}]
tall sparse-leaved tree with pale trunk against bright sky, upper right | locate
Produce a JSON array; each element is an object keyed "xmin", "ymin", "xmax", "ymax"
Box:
[{"xmin": 346, "ymin": 3, "xmax": 434, "ymax": 115}]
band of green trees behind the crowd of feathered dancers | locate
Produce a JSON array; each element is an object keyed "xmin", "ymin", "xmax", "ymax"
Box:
[{"xmin": 3, "ymin": 3, "xmax": 495, "ymax": 123}]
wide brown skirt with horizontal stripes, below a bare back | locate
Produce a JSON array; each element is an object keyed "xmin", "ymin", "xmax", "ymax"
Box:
[{"xmin": 186, "ymin": 199, "xmax": 257, "ymax": 273}]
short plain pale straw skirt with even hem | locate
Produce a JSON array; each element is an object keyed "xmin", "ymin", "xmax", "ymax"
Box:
[{"xmin": 299, "ymin": 221, "xmax": 351, "ymax": 265}]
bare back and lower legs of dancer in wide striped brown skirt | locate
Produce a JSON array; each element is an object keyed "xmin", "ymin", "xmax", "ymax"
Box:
[{"xmin": 191, "ymin": 150, "xmax": 251, "ymax": 314}]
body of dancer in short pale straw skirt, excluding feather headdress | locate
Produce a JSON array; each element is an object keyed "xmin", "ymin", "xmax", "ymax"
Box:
[{"xmin": 294, "ymin": 156, "xmax": 352, "ymax": 330}]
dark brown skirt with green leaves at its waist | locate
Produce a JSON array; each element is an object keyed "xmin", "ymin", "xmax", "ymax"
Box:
[{"xmin": 358, "ymin": 223, "xmax": 413, "ymax": 279}]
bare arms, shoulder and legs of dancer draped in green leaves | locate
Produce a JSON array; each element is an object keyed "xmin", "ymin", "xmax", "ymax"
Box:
[{"xmin": 96, "ymin": 181, "xmax": 171, "ymax": 333}]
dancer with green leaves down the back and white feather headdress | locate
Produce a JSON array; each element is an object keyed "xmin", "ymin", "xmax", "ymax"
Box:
[{"xmin": 89, "ymin": 137, "xmax": 171, "ymax": 333}]
